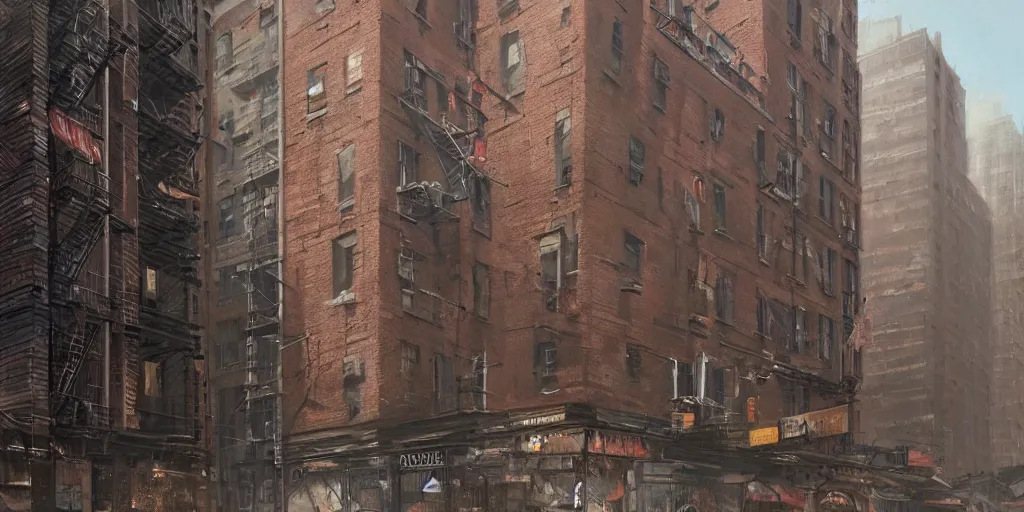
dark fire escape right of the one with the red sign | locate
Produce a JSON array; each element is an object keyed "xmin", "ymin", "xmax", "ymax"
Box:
[{"xmin": 137, "ymin": 0, "xmax": 203, "ymax": 441}]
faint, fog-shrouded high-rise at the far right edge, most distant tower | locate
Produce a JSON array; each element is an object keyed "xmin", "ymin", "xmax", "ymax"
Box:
[{"xmin": 968, "ymin": 99, "xmax": 1024, "ymax": 468}]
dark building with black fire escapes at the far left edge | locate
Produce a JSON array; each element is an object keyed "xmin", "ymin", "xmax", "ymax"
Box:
[{"xmin": 0, "ymin": 0, "xmax": 208, "ymax": 511}]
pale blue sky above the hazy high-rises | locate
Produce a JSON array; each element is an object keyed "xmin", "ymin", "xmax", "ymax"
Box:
[{"xmin": 858, "ymin": 0, "xmax": 1024, "ymax": 124}]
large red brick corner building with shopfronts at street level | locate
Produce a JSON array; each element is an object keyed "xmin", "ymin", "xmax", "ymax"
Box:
[{"xmin": 264, "ymin": 0, "xmax": 860, "ymax": 510}]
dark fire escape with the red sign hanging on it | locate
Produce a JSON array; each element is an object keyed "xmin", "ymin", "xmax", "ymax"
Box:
[{"xmin": 48, "ymin": 0, "xmax": 130, "ymax": 435}]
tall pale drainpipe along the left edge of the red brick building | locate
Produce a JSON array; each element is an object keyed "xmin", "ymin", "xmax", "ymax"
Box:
[{"xmin": 273, "ymin": 0, "xmax": 288, "ymax": 512}]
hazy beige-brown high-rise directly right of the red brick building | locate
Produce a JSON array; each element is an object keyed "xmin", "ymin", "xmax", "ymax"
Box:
[{"xmin": 860, "ymin": 20, "xmax": 993, "ymax": 475}]
